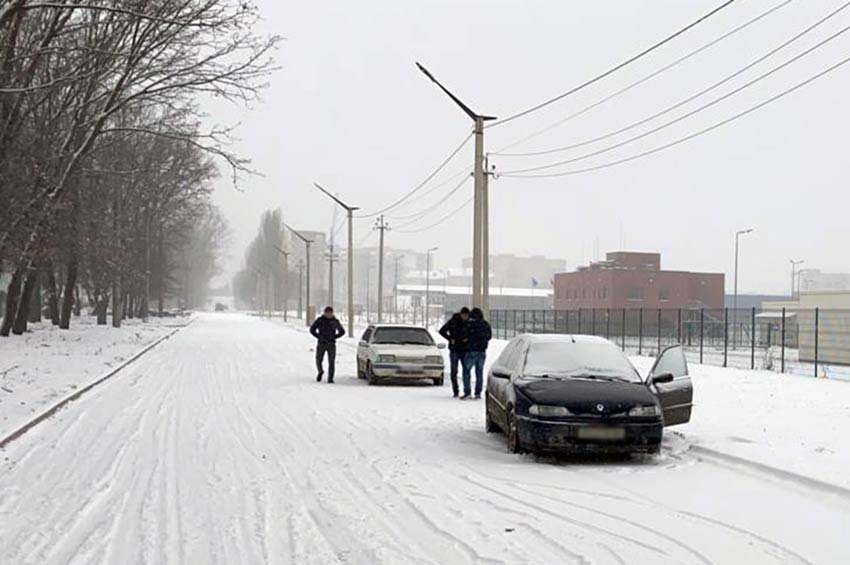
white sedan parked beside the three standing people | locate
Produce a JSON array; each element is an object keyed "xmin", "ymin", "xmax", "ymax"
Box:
[{"xmin": 357, "ymin": 324, "xmax": 445, "ymax": 386}]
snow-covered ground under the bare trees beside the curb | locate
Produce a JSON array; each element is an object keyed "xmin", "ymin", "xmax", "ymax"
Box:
[{"xmin": 0, "ymin": 317, "xmax": 186, "ymax": 438}]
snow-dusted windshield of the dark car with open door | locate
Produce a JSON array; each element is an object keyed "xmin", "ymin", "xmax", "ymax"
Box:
[{"xmin": 524, "ymin": 341, "xmax": 642, "ymax": 383}]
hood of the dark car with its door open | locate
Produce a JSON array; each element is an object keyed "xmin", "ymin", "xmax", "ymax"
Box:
[{"xmin": 514, "ymin": 378, "xmax": 658, "ymax": 416}]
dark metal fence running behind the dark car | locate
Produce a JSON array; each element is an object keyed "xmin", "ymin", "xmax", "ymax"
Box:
[{"xmin": 490, "ymin": 308, "xmax": 850, "ymax": 380}]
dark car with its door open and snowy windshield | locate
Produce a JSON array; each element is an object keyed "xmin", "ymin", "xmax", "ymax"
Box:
[{"xmin": 485, "ymin": 334, "xmax": 693, "ymax": 454}]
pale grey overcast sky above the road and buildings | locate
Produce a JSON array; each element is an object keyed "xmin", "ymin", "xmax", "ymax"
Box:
[{"xmin": 212, "ymin": 0, "xmax": 850, "ymax": 293}]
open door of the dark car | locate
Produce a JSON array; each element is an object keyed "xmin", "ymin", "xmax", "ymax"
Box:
[{"xmin": 647, "ymin": 345, "xmax": 694, "ymax": 426}]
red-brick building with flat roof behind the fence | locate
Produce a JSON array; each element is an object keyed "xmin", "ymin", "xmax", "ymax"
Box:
[{"xmin": 554, "ymin": 251, "xmax": 725, "ymax": 310}]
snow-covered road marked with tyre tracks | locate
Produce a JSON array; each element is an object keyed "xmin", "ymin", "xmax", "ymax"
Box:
[{"xmin": 0, "ymin": 315, "xmax": 850, "ymax": 564}]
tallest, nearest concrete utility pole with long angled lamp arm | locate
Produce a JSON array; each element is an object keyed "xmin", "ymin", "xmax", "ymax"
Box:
[{"xmin": 416, "ymin": 63, "xmax": 496, "ymax": 308}]
